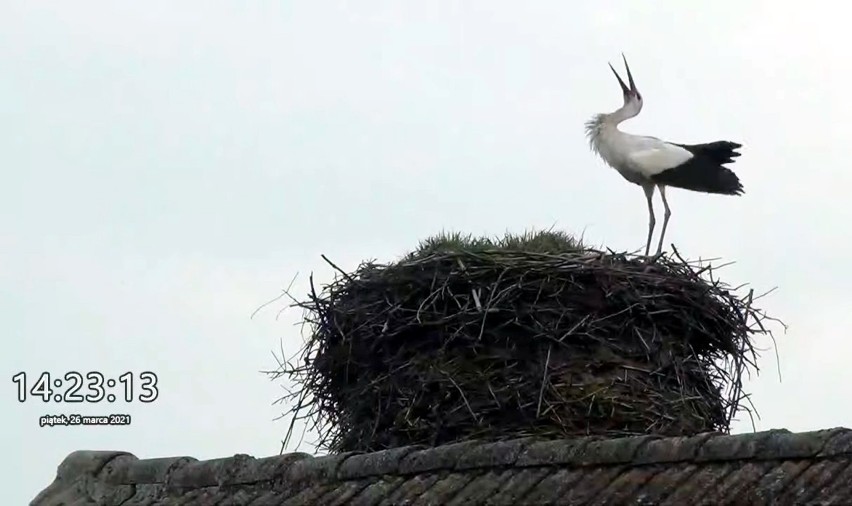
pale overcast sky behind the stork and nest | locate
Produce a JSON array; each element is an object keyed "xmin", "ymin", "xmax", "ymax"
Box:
[{"xmin": 0, "ymin": 0, "xmax": 852, "ymax": 504}]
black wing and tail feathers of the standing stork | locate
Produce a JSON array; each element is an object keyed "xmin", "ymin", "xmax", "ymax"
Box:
[{"xmin": 653, "ymin": 141, "xmax": 744, "ymax": 195}]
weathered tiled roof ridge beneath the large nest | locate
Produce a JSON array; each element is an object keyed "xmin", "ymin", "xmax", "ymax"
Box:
[{"xmin": 31, "ymin": 428, "xmax": 852, "ymax": 506}]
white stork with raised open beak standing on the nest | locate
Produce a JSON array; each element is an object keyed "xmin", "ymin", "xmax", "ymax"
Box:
[{"xmin": 586, "ymin": 54, "xmax": 743, "ymax": 257}]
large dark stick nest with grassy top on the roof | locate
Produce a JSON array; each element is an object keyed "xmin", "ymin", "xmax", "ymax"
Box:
[{"xmin": 276, "ymin": 233, "xmax": 766, "ymax": 452}]
